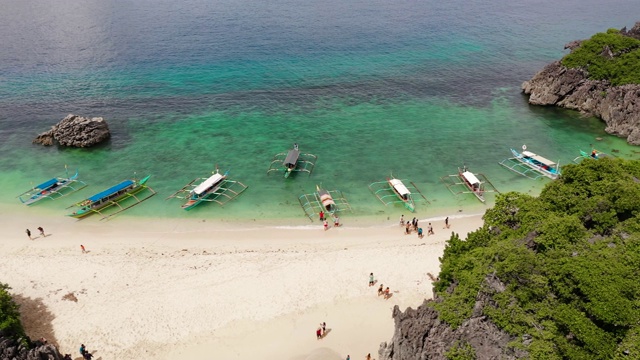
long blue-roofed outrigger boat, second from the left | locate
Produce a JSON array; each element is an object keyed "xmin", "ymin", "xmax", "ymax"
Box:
[{"xmin": 67, "ymin": 175, "xmax": 156, "ymax": 220}]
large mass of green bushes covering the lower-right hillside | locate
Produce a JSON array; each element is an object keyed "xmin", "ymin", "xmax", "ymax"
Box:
[{"xmin": 432, "ymin": 159, "xmax": 640, "ymax": 359}]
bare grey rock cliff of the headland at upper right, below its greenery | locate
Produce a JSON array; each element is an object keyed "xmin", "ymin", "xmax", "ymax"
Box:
[{"xmin": 522, "ymin": 22, "xmax": 640, "ymax": 145}]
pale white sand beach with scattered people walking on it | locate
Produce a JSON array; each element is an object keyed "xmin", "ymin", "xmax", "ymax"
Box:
[{"xmin": 0, "ymin": 212, "xmax": 482, "ymax": 360}]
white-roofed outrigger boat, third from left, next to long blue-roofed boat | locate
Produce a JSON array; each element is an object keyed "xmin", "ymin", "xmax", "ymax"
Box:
[{"xmin": 165, "ymin": 168, "xmax": 247, "ymax": 211}]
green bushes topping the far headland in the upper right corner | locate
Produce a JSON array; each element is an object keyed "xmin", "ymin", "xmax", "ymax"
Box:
[{"xmin": 562, "ymin": 29, "xmax": 640, "ymax": 86}]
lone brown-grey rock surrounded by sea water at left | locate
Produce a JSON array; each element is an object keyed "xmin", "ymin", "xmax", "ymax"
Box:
[{"xmin": 33, "ymin": 114, "xmax": 111, "ymax": 147}]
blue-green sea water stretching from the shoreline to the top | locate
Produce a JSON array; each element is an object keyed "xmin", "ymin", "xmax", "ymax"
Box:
[{"xmin": 0, "ymin": 0, "xmax": 640, "ymax": 221}]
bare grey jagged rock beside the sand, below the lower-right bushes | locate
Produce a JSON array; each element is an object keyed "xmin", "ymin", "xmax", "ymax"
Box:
[{"xmin": 378, "ymin": 277, "xmax": 528, "ymax": 360}]
